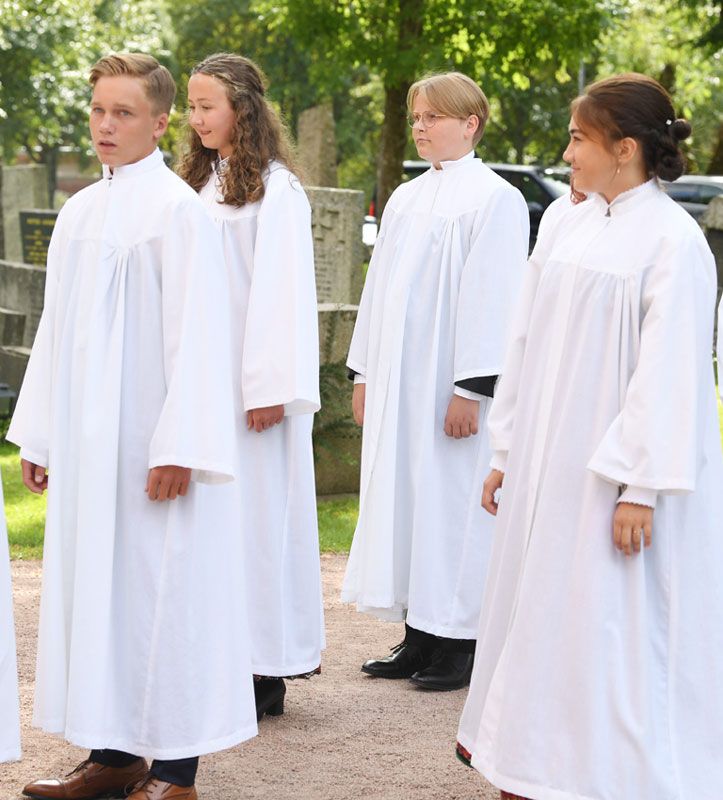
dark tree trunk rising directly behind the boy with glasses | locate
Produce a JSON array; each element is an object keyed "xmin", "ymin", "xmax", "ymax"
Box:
[{"xmin": 376, "ymin": 0, "xmax": 425, "ymax": 219}]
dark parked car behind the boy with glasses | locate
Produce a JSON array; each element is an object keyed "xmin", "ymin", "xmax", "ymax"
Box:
[{"xmin": 363, "ymin": 161, "xmax": 570, "ymax": 250}]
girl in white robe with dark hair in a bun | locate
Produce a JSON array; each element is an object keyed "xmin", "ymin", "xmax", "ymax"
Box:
[{"xmin": 458, "ymin": 74, "xmax": 723, "ymax": 800}]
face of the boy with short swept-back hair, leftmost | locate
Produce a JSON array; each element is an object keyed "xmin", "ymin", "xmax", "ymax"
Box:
[{"xmin": 90, "ymin": 75, "xmax": 168, "ymax": 167}]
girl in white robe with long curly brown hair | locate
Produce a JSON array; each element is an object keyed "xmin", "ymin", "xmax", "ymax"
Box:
[{"xmin": 179, "ymin": 53, "xmax": 324, "ymax": 719}]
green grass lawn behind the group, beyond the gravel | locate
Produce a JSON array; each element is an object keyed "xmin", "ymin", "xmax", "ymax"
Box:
[{"xmin": 5, "ymin": 400, "xmax": 723, "ymax": 559}]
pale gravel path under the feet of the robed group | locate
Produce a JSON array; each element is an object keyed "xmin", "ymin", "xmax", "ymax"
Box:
[{"xmin": 0, "ymin": 555, "xmax": 498, "ymax": 800}]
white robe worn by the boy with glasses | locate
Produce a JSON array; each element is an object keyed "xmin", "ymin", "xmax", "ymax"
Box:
[{"xmin": 342, "ymin": 153, "xmax": 529, "ymax": 639}]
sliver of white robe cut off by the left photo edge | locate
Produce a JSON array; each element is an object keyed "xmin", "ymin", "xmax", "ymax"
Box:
[{"xmin": 0, "ymin": 484, "xmax": 20, "ymax": 763}]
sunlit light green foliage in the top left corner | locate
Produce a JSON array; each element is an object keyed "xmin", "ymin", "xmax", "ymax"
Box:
[{"xmin": 0, "ymin": 0, "xmax": 172, "ymax": 197}]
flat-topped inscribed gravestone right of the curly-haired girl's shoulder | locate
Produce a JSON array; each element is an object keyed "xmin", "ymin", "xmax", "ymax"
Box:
[{"xmin": 306, "ymin": 187, "xmax": 366, "ymax": 305}]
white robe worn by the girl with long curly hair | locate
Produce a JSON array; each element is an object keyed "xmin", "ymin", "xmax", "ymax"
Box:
[{"xmin": 200, "ymin": 162, "xmax": 325, "ymax": 677}]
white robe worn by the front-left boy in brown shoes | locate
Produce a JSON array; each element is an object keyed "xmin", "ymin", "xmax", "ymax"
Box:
[{"xmin": 8, "ymin": 150, "xmax": 256, "ymax": 759}]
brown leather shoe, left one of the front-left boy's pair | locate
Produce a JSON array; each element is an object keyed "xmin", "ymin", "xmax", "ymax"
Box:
[{"xmin": 23, "ymin": 758, "xmax": 148, "ymax": 800}]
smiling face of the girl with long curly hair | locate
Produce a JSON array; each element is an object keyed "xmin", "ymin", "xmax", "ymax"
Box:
[{"xmin": 188, "ymin": 73, "xmax": 236, "ymax": 158}]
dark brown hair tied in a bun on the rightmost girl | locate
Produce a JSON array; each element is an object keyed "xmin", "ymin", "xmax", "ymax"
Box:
[{"xmin": 571, "ymin": 72, "xmax": 691, "ymax": 181}]
